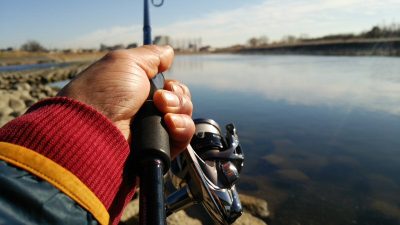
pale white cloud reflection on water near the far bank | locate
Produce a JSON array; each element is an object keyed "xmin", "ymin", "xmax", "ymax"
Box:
[{"xmin": 166, "ymin": 55, "xmax": 400, "ymax": 115}]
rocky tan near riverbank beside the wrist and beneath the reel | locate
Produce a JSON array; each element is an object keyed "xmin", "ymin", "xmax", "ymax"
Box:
[{"xmin": 0, "ymin": 62, "xmax": 270, "ymax": 225}]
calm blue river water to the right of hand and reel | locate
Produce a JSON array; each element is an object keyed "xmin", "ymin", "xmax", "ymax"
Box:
[{"xmin": 166, "ymin": 55, "xmax": 400, "ymax": 225}]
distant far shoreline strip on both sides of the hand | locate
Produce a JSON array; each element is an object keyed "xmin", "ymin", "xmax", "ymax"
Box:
[{"xmin": 0, "ymin": 38, "xmax": 400, "ymax": 67}]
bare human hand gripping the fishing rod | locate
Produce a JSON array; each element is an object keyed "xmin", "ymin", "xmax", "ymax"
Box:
[{"xmin": 58, "ymin": 46, "xmax": 195, "ymax": 158}]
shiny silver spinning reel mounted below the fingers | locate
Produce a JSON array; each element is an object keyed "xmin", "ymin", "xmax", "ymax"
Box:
[{"xmin": 166, "ymin": 119, "xmax": 244, "ymax": 224}]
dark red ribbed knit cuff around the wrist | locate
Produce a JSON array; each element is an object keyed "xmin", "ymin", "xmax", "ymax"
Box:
[{"xmin": 0, "ymin": 97, "xmax": 135, "ymax": 224}]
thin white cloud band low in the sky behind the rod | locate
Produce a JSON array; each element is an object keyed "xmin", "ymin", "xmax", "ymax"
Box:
[{"xmin": 70, "ymin": 0, "xmax": 400, "ymax": 46}]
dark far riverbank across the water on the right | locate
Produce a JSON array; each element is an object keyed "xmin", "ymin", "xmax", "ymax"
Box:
[{"xmin": 231, "ymin": 38, "xmax": 400, "ymax": 56}]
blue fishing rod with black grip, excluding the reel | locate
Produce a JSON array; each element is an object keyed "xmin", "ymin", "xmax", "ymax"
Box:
[{"xmin": 131, "ymin": 0, "xmax": 171, "ymax": 225}]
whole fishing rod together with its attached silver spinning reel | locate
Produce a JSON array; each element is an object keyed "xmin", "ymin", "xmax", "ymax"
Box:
[{"xmin": 131, "ymin": 0, "xmax": 244, "ymax": 225}]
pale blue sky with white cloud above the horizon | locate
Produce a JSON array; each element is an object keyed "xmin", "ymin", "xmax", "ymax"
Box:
[{"xmin": 0, "ymin": 0, "xmax": 400, "ymax": 48}]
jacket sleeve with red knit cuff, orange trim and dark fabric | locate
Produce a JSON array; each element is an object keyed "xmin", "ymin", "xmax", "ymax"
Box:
[{"xmin": 0, "ymin": 98, "xmax": 135, "ymax": 224}]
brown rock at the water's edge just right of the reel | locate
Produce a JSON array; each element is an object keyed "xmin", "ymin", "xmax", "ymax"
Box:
[{"xmin": 239, "ymin": 194, "xmax": 270, "ymax": 220}]
